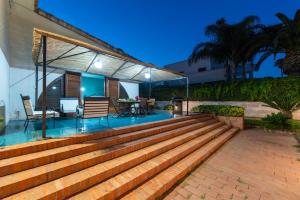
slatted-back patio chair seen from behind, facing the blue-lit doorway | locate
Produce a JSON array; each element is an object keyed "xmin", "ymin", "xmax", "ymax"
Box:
[{"xmin": 76, "ymin": 97, "xmax": 110, "ymax": 128}]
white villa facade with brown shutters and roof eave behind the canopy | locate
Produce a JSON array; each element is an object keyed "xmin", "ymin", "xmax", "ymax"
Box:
[{"xmin": 0, "ymin": 0, "xmax": 144, "ymax": 123}]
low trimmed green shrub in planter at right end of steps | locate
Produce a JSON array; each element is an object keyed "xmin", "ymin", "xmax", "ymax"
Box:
[{"xmin": 192, "ymin": 105, "xmax": 244, "ymax": 117}]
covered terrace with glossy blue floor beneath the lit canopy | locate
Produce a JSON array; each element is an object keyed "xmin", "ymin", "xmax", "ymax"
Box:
[{"xmin": 0, "ymin": 29, "xmax": 188, "ymax": 146}]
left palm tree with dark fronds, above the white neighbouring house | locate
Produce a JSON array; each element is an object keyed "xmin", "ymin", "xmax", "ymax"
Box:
[{"xmin": 189, "ymin": 16, "xmax": 260, "ymax": 80}]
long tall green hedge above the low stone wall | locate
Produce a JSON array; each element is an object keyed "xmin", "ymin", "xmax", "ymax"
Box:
[{"xmin": 140, "ymin": 77, "xmax": 300, "ymax": 101}]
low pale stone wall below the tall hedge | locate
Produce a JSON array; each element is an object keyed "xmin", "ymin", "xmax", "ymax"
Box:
[{"xmin": 157, "ymin": 101, "xmax": 300, "ymax": 120}]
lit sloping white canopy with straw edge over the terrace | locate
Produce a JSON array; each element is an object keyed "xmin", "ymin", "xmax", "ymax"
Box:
[{"xmin": 32, "ymin": 29, "xmax": 184, "ymax": 82}]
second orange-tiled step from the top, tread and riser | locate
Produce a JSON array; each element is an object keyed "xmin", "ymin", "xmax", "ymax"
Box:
[{"xmin": 0, "ymin": 117, "xmax": 211, "ymax": 176}]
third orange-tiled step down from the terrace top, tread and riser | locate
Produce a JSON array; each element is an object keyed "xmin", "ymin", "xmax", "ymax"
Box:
[{"xmin": 0, "ymin": 120, "xmax": 222, "ymax": 197}]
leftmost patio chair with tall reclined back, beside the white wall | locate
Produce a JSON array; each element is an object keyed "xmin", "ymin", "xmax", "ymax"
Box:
[{"xmin": 20, "ymin": 94, "xmax": 59, "ymax": 130}]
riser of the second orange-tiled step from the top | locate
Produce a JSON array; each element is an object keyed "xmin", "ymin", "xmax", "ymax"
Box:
[{"xmin": 0, "ymin": 117, "xmax": 210, "ymax": 177}]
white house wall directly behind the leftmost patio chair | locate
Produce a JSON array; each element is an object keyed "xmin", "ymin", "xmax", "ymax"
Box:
[{"xmin": 9, "ymin": 67, "xmax": 62, "ymax": 119}]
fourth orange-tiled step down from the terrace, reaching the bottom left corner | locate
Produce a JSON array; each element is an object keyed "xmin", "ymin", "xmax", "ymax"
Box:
[{"xmin": 7, "ymin": 124, "xmax": 229, "ymax": 199}]
